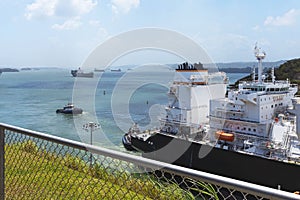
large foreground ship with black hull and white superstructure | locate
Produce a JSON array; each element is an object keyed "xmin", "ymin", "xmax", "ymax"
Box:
[{"xmin": 122, "ymin": 46, "xmax": 300, "ymax": 192}]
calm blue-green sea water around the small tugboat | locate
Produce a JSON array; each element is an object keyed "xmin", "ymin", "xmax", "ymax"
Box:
[{"xmin": 0, "ymin": 69, "xmax": 247, "ymax": 150}]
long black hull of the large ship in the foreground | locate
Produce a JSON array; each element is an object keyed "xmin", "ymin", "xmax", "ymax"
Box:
[{"xmin": 131, "ymin": 133, "xmax": 300, "ymax": 192}]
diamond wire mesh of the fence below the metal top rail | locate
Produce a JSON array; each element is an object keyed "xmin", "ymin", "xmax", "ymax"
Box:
[{"xmin": 1, "ymin": 126, "xmax": 298, "ymax": 200}]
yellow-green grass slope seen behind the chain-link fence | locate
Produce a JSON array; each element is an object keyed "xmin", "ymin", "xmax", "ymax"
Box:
[{"xmin": 5, "ymin": 141, "xmax": 196, "ymax": 200}]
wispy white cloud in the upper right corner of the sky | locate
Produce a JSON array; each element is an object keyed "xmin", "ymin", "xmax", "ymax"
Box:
[{"xmin": 264, "ymin": 9, "xmax": 300, "ymax": 26}]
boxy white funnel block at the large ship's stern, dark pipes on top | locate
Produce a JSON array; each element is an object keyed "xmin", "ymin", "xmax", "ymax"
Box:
[{"xmin": 161, "ymin": 63, "xmax": 227, "ymax": 135}]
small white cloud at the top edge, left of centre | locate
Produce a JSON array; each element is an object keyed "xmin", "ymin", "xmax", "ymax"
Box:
[{"xmin": 111, "ymin": 0, "xmax": 140, "ymax": 14}]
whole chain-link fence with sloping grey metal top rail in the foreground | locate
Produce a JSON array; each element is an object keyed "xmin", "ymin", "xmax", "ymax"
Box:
[{"xmin": 0, "ymin": 124, "xmax": 300, "ymax": 200}]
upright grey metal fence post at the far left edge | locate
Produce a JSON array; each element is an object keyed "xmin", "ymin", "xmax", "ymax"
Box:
[{"xmin": 0, "ymin": 126, "xmax": 5, "ymax": 200}]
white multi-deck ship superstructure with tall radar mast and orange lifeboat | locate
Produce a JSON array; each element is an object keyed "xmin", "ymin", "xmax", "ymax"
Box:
[{"xmin": 207, "ymin": 47, "xmax": 300, "ymax": 161}]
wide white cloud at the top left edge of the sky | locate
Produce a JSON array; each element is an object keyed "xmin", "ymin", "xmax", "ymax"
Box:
[{"xmin": 25, "ymin": 0, "xmax": 97, "ymax": 20}]
